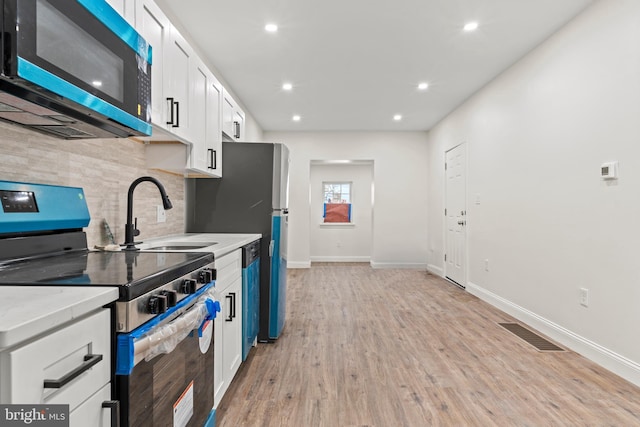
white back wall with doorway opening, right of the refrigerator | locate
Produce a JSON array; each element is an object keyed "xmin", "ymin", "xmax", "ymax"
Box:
[{"xmin": 264, "ymin": 132, "xmax": 427, "ymax": 268}]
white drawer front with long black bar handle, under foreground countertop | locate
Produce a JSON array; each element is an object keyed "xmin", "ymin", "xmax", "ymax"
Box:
[{"xmin": 1, "ymin": 309, "xmax": 111, "ymax": 411}]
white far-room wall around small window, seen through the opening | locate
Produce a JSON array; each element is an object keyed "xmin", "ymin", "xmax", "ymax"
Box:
[{"xmin": 309, "ymin": 162, "xmax": 374, "ymax": 262}]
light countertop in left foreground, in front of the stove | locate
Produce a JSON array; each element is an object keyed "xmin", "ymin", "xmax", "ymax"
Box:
[{"xmin": 0, "ymin": 286, "xmax": 118, "ymax": 350}]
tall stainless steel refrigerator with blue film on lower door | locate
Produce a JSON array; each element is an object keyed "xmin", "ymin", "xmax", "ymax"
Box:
[{"xmin": 186, "ymin": 142, "xmax": 289, "ymax": 342}]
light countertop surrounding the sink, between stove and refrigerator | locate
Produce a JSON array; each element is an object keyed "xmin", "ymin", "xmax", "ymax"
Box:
[{"xmin": 137, "ymin": 233, "xmax": 262, "ymax": 258}]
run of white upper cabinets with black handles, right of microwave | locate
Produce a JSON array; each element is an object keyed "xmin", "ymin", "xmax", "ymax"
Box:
[{"xmin": 135, "ymin": 0, "xmax": 235, "ymax": 177}]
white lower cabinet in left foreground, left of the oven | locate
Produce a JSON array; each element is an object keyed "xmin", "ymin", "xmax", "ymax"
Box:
[{"xmin": 0, "ymin": 309, "xmax": 115, "ymax": 427}]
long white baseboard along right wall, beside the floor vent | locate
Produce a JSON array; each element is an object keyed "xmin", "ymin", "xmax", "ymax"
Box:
[{"xmin": 466, "ymin": 282, "xmax": 640, "ymax": 386}]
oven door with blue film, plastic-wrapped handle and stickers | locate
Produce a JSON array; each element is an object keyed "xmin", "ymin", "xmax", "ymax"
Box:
[{"xmin": 116, "ymin": 282, "xmax": 220, "ymax": 427}]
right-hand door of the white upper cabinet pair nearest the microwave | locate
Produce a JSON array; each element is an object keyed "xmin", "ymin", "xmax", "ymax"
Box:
[{"xmin": 164, "ymin": 26, "xmax": 193, "ymax": 141}]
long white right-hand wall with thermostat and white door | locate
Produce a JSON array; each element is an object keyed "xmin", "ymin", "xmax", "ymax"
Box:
[{"xmin": 428, "ymin": 0, "xmax": 640, "ymax": 384}]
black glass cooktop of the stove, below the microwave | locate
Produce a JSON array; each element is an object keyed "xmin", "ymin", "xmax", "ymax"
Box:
[{"xmin": 0, "ymin": 251, "xmax": 213, "ymax": 301}]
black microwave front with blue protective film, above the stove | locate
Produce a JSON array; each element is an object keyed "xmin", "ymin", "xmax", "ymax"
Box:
[{"xmin": 2, "ymin": 0, "xmax": 151, "ymax": 132}]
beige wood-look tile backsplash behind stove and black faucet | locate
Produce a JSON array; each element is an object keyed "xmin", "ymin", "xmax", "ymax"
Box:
[{"xmin": 0, "ymin": 122, "xmax": 185, "ymax": 247}]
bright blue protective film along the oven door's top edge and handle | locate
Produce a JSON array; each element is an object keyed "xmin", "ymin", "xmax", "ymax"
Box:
[{"xmin": 116, "ymin": 281, "xmax": 220, "ymax": 375}]
